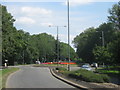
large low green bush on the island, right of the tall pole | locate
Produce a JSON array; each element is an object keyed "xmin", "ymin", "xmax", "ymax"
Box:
[{"xmin": 69, "ymin": 69, "xmax": 109, "ymax": 83}]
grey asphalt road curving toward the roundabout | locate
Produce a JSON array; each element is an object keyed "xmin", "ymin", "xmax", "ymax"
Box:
[{"xmin": 6, "ymin": 66, "xmax": 74, "ymax": 88}]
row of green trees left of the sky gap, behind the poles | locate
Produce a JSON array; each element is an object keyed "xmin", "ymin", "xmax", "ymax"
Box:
[{"xmin": 0, "ymin": 5, "xmax": 77, "ymax": 65}]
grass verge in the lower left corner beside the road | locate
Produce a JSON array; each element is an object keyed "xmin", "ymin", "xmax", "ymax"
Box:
[{"xmin": 0, "ymin": 68, "xmax": 19, "ymax": 89}]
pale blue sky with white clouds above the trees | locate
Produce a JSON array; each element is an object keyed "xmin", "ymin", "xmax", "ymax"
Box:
[{"xmin": 0, "ymin": 0, "xmax": 118, "ymax": 47}]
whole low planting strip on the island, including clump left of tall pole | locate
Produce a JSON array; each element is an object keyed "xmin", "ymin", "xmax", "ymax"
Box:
[{"xmin": 57, "ymin": 67, "xmax": 110, "ymax": 83}]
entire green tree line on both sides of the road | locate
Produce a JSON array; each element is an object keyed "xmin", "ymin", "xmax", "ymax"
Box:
[{"xmin": 0, "ymin": 2, "xmax": 120, "ymax": 65}]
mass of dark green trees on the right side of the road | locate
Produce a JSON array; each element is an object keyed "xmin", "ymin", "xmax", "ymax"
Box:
[{"xmin": 73, "ymin": 2, "xmax": 120, "ymax": 65}]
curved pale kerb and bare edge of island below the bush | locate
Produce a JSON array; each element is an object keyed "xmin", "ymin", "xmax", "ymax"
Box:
[{"xmin": 50, "ymin": 68, "xmax": 120, "ymax": 90}]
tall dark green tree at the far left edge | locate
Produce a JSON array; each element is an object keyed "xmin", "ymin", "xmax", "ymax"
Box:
[{"xmin": 0, "ymin": 6, "xmax": 16, "ymax": 64}]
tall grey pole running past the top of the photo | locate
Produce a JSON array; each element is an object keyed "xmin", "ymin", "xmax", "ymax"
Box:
[{"xmin": 67, "ymin": 0, "xmax": 70, "ymax": 71}]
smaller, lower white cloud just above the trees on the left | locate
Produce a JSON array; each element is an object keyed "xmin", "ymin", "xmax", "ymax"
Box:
[{"xmin": 16, "ymin": 17, "xmax": 35, "ymax": 24}]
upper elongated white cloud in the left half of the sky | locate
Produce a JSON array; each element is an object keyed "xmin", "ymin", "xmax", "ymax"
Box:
[{"xmin": 21, "ymin": 7, "xmax": 52, "ymax": 16}]
